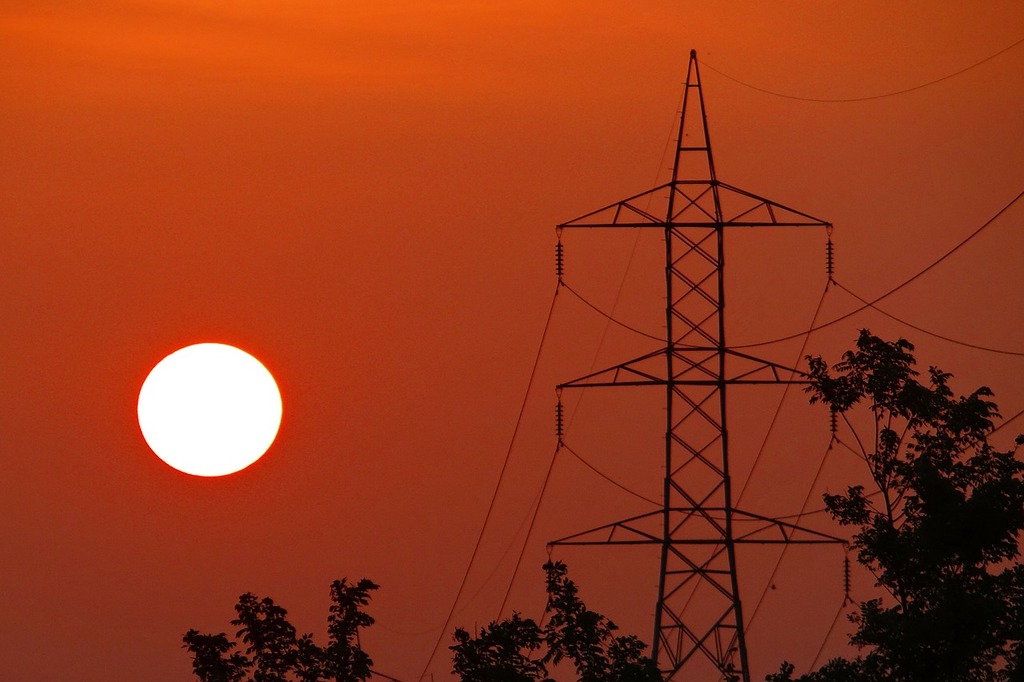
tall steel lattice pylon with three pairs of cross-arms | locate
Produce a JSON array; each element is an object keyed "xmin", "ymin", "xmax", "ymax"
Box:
[{"xmin": 551, "ymin": 51, "xmax": 839, "ymax": 682}]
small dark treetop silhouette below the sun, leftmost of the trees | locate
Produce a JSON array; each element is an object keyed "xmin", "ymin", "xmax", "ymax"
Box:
[{"xmin": 182, "ymin": 579, "xmax": 378, "ymax": 682}]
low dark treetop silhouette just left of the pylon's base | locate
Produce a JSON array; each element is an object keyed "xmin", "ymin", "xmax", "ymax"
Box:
[{"xmin": 451, "ymin": 561, "xmax": 660, "ymax": 682}]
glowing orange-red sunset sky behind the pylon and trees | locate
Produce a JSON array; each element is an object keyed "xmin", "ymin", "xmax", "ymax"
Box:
[{"xmin": 0, "ymin": 0, "xmax": 1024, "ymax": 682}]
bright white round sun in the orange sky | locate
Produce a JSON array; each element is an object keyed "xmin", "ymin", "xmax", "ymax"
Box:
[{"xmin": 138, "ymin": 343, "xmax": 282, "ymax": 476}]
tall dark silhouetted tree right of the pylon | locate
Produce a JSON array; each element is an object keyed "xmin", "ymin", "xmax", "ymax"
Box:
[{"xmin": 767, "ymin": 331, "xmax": 1024, "ymax": 682}]
